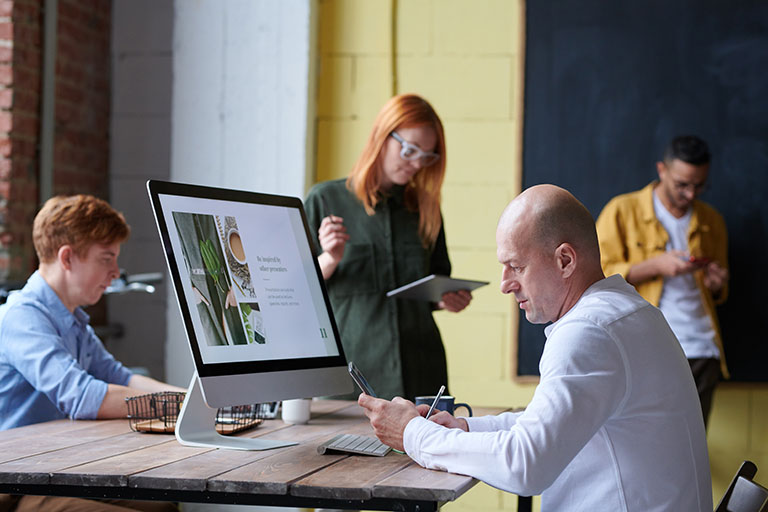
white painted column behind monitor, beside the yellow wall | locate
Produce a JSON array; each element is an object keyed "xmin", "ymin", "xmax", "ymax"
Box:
[{"xmin": 166, "ymin": 0, "xmax": 316, "ymax": 383}]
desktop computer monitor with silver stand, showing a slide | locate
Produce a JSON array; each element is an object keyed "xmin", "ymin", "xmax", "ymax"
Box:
[{"xmin": 147, "ymin": 180, "xmax": 352, "ymax": 449}]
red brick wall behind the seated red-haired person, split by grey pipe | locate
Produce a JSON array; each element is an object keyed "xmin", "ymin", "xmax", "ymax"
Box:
[{"xmin": 0, "ymin": 0, "xmax": 111, "ymax": 282}]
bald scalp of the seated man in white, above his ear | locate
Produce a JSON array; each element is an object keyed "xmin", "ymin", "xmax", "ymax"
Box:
[{"xmin": 498, "ymin": 185, "xmax": 600, "ymax": 267}]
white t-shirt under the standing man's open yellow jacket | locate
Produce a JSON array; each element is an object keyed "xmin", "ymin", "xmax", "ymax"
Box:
[{"xmin": 653, "ymin": 191, "xmax": 720, "ymax": 359}]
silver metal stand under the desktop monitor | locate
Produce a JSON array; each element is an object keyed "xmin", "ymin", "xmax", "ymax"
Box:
[{"xmin": 176, "ymin": 372, "xmax": 298, "ymax": 450}]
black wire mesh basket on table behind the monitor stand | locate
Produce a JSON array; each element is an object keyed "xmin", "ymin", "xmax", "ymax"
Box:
[{"xmin": 125, "ymin": 391, "xmax": 279, "ymax": 435}]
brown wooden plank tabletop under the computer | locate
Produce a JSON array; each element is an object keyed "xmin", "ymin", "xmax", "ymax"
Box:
[{"xmin": 0, "ymin": 400, "xmax": 528, "ymax": 511}]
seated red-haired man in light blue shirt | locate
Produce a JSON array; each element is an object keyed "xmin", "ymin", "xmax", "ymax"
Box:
[{"xmin": 0, "ymin": 195, "xmax": 180, "ymax": 430}]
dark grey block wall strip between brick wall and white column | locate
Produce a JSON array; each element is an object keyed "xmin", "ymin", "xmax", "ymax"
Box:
[{"xmin": 105, "ymin": 0, "xmax": 173, "ymax": 379}]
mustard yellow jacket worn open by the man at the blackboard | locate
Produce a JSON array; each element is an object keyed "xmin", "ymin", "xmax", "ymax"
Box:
[{"xmin": 597, "ymin": 181, "xmax": 729, "ymax": 378}]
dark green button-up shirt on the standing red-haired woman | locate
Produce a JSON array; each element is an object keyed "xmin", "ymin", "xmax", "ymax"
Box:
[{"xmin": 306, "ymin": 180, "xmax": 451, "ymax": 399}]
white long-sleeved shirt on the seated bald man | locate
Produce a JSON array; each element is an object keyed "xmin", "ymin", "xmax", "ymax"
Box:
[{"xmin": 404, "ymin": 275, "xmax": 712, "ymax": 512}]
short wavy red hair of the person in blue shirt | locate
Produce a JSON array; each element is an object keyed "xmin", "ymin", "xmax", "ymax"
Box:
[{"xmin": 32, "ymin": 194, "xmax": 131, "ymax": 263}]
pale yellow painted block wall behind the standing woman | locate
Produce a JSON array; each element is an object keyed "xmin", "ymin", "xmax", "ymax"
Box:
[{"xmin": 316, "ymin": 0, "xmax": 768, "ymax": 512}]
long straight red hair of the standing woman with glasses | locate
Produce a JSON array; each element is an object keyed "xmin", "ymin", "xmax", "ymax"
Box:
[{"xmin": 347, "ymin": 94, "xmax": 445, "ymax": 247}]
